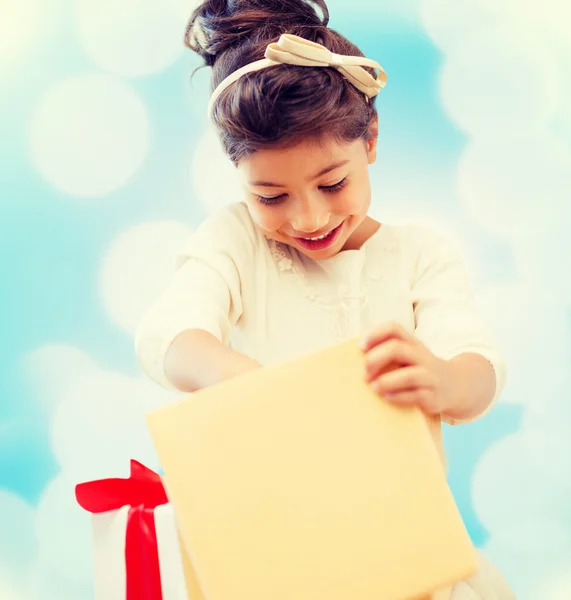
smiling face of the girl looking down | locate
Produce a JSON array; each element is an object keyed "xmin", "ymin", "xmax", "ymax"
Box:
[{"xmin": 238, "ymin": 131, "xmax": 376, "ymax": 260}]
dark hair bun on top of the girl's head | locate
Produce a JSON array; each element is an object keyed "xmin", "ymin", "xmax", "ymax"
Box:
[{"xmin": 185, "ymin": 0, "xmax": 329, "ymax": 66}]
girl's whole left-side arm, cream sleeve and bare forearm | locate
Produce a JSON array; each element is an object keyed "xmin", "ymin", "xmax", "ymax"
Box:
[{"xmin": 135, "ymin": 206, "xmax": 259, "ymax": 392}]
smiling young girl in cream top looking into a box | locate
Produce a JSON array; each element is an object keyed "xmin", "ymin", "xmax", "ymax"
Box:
[{"xmin": 136, "ymin": 0, "xmax": 514, "ymax": 600}]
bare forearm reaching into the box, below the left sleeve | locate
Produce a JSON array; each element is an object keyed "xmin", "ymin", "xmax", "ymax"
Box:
[{"xmin": 165, "ymin": 329, "xmax": 261, "ymax": 392}]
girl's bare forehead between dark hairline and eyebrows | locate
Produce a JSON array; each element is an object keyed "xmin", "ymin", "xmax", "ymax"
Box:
[{"xmin": 238, "ymin": 138, "xmax": 364, "ymax": 179}]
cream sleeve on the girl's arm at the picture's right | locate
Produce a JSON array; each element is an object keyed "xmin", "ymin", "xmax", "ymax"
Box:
[{"xmin": 411, "ymin": 228, "xmax": 506, "ymax": 425}]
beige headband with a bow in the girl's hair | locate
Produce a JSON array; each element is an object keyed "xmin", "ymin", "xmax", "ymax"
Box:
[{"xmin": 208, "ymin": 33, "xmax": 387, "ymax": 115}]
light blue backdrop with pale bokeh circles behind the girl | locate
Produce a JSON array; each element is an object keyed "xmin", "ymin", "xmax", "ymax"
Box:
[{"xmin": 0, "ymin": 0, "xmax": 571, "ymax": 600}]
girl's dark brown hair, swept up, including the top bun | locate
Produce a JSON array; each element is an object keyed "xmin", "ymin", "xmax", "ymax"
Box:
[{"xmin": 185, "ymin": 0, "xmax": 376, "ymax": 163}]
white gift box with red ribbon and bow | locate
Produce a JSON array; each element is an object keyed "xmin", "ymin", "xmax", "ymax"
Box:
[{"xmin": 76, "ymin": 460, "xmax": 204, "ymax": 600}]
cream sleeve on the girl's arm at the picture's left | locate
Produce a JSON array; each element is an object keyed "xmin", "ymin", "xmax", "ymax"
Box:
[{"xmin": 135, "ymin": 206, "xmax": 253, "ymax": 389}]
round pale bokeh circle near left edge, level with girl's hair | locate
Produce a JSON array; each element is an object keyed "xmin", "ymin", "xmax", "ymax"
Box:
[{"xmin": 30, "ymin": 75, "xmax": 149, "ymax": 198}]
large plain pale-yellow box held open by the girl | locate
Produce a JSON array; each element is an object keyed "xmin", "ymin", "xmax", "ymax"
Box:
[{"xmin": 147, "ymin": 340, "xmax": 478, "ymax": 600}]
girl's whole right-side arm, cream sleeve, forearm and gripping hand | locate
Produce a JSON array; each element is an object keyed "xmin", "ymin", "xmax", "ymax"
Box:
[{"xmin": 363, "ymin": 230, "xmax": 505, "ymax": 424}]
